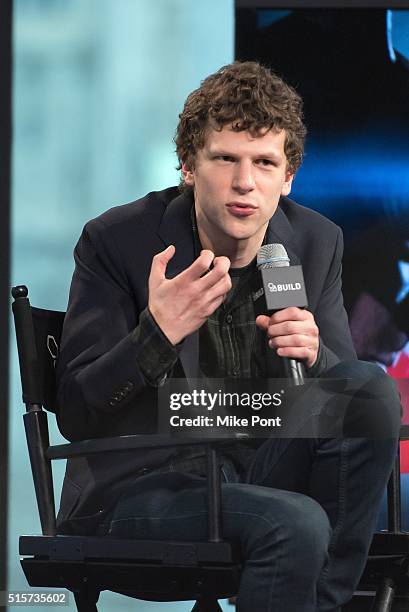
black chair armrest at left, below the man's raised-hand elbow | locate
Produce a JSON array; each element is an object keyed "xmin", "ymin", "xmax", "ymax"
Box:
[{"xmin": 45, "ymin": 434, "xmax": 225, "ymax": 459}]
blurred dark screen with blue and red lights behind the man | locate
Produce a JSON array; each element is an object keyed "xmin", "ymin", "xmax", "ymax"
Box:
[{"xmin": 236, "ymin": 1, "xmax": 409, "ymax": 528}]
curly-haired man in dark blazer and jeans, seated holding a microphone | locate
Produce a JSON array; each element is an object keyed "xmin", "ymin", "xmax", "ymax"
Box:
[{"xmin": 57, "ymin": 62, "xmax": 399, "ymax": 612}]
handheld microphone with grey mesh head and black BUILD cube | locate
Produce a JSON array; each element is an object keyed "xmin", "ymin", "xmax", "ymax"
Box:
[{"xmin": 257, "ymin": 244, "xmax": 308, "ymax": 386}]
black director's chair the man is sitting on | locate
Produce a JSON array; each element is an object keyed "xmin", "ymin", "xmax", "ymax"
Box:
[{"xmin": 12, "ymin": 286, "xmax": 241, "ymax": 612}]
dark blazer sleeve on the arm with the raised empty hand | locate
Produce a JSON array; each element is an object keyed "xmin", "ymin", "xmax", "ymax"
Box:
[{"xmin": 57, "ymin": 219, "xmax": 177, "ymax": 440}]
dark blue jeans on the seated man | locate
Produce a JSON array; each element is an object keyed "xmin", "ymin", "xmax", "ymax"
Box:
[{"xmin": 101, "ymin": 361, "xmax": 400, "ymax": 612}]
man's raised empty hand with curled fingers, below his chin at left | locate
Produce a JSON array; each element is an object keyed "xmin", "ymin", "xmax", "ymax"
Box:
[{"xmin": 148, "ymin": 245, "xmax": 231, "ymax": 345}]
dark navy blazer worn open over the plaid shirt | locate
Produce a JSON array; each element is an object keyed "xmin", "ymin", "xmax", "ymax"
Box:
[{"xmin": 57, "ymin": 187, "xmax": 356, "ymax": 531}]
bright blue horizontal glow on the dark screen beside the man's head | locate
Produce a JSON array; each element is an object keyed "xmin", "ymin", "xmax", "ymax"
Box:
[{"xmin": 292, "ymin": 133, "xmax": 409, "ymax": 215}]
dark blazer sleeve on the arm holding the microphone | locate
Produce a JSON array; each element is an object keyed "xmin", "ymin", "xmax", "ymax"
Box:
[{"xmin": 308, "ymin": 227, "xmax": 357, "ymax": 377}]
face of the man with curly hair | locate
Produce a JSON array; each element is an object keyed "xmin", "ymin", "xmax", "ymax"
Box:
[{"xmin": 182, "ymin": 126, "xmax": 293, "ymax": 248}]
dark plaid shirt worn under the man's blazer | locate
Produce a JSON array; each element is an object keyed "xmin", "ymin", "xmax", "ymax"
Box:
[{"xmin": 134, "ymin": 207, "xmax": 325, "ymax": 475}]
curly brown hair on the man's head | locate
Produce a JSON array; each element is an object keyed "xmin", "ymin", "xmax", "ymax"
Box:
[{"xmin": 175, "ymin": 61, "xmax": 307, "ymax": 186}]
